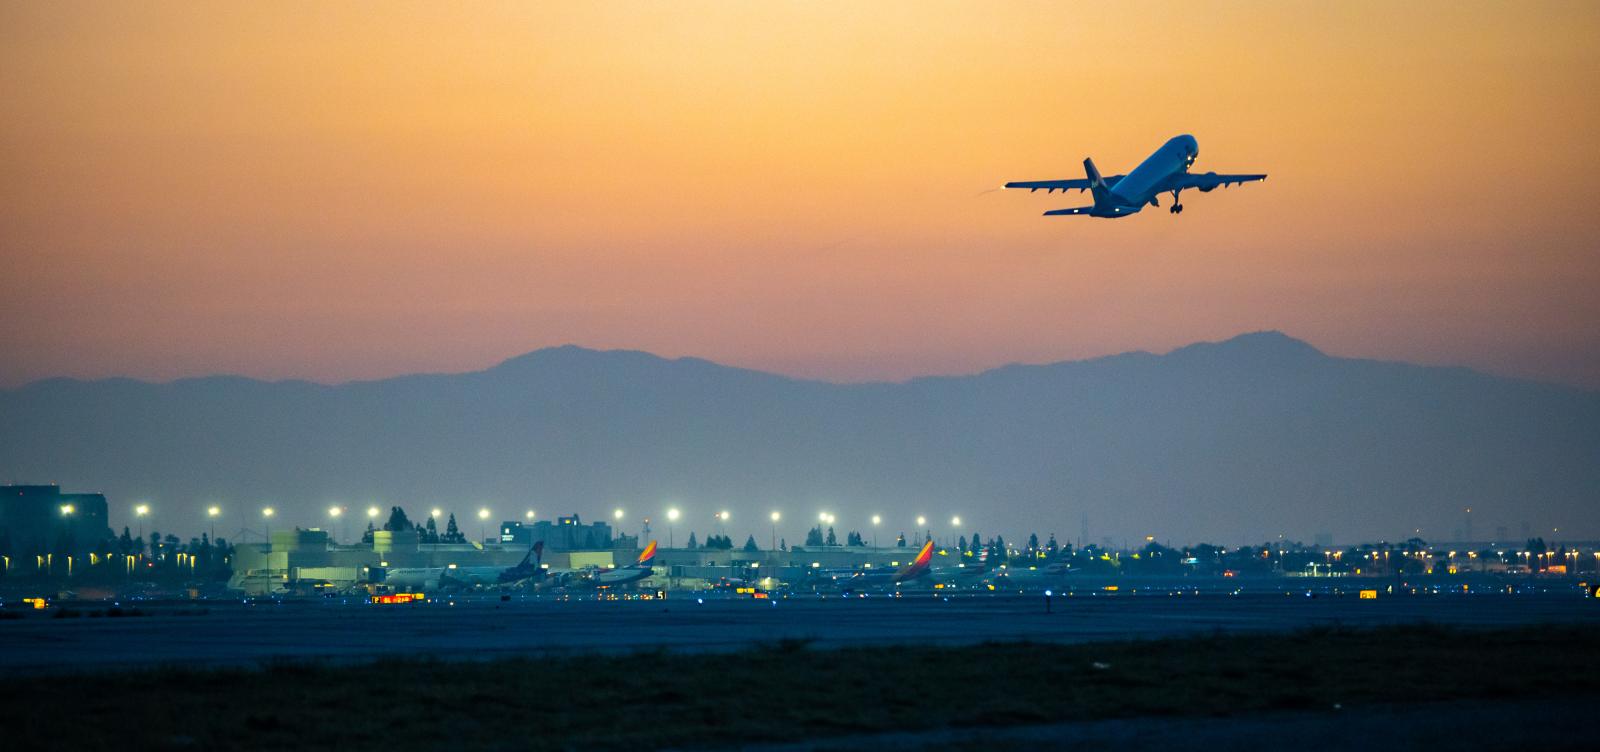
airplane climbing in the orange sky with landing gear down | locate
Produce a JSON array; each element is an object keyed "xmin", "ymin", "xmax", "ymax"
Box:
[{"xmin": 1005, "ymin": 134, "xmax": 1267, "ymax": 218}]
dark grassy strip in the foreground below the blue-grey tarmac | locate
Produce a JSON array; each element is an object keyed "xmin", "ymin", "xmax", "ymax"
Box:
[{"xmin": 0, "ymin": 626, "xmax": 1600, "ymax": 752}]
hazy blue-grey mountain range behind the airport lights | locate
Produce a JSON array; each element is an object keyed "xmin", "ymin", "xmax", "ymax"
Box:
[{"xmin": 0, "ymin": 333, "xmax": 1600, "ymax": 544}]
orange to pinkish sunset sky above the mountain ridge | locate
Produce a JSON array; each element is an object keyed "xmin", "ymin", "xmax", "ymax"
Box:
[{"xmin": 0, "ymin": 0, "xmax": 1600, "ymax": 387}]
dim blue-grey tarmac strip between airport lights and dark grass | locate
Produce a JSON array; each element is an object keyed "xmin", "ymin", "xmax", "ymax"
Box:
[{"xmin": 0, "ymin": 592, "xmax": 1600, "ymax": 674}]
